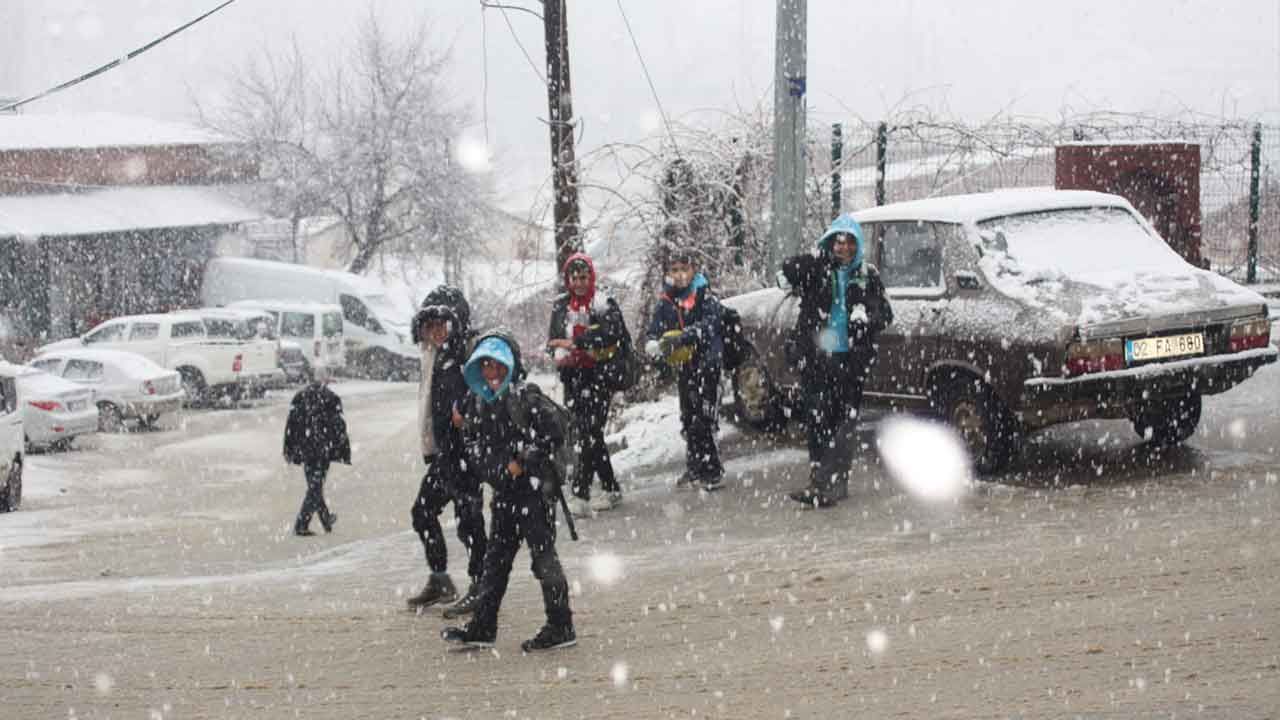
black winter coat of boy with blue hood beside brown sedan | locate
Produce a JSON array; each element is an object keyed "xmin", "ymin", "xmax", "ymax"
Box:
[{"xmin": 782, "ymin": 254, "xmax": 893, "ymax": 368}]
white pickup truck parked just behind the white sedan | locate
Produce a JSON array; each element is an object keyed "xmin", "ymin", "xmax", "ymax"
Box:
[{"xmin": 36, "ymin": 313, "xmax": 251, "ymax": 402}]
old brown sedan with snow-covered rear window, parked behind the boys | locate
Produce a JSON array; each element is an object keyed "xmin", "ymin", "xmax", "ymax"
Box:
[{"xmin": 726, "ymin": 190, "xmax": 1276, "ymax": 473}]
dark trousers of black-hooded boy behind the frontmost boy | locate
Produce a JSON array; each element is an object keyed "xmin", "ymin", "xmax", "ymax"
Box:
[{"xmin": 410, "ymin": 457, "xmax": 486, "ymax": 580}]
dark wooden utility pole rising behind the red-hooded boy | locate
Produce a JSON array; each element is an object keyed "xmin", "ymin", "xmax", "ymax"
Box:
[{"xmin": 543, "ymin": 0, "xmax": 582, "ymax": 268}]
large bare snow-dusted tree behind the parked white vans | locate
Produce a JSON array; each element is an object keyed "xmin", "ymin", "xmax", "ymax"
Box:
[{"xmin": 201, "ymin": 14, "xmax": 488, "ymax": 273}]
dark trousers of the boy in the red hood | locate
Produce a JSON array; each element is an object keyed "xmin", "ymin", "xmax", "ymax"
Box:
[{"xmin": 561, "ymin": 369, "xmax": 622, "ymax": 500}]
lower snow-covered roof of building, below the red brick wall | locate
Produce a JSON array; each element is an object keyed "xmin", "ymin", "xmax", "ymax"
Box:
[{"xmin": 0, "ymin": 183, "xmax": 261, "ymax": 237}]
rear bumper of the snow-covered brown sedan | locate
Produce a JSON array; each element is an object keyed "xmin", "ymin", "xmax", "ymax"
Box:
[{"xmin": 1019, "ymin": 347, "xmax": 1280, "ymax": 427}]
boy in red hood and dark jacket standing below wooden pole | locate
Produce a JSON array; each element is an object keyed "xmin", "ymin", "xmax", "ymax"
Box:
[{"xmin": 547, "ymin": 252, "xmax": 626, "ymax": 516}]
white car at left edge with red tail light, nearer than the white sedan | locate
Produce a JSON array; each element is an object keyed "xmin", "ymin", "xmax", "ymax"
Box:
[{"xmin": 18, "ymin": 368, "xmax": 97, "ymax": 452}]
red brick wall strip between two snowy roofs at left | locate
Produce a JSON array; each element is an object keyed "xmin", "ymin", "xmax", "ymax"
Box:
[{"xmin": 0, "ymin": 145, "xmax": 257, "ymax": 195}]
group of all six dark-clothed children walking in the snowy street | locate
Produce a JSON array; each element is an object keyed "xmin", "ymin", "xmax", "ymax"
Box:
[{"xmin": 284, "ymin": 215, "xmax": 892, "ymax": 652}]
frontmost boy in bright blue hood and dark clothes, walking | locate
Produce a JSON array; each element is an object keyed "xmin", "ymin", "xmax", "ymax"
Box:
[{"xmin": 440, "ymin": 332, "xmax": 577, "ymax": 652}]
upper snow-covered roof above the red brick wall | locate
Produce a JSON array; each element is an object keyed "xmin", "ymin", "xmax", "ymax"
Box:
[{"xmin": 0, "ymin": 113, "xmax": 232, "ymax": 150}]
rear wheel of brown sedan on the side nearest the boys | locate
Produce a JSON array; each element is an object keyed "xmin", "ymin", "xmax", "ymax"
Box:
[{"xmin": 929, "ymin": 377, "xmax": 1021, "ymax": 475}]
